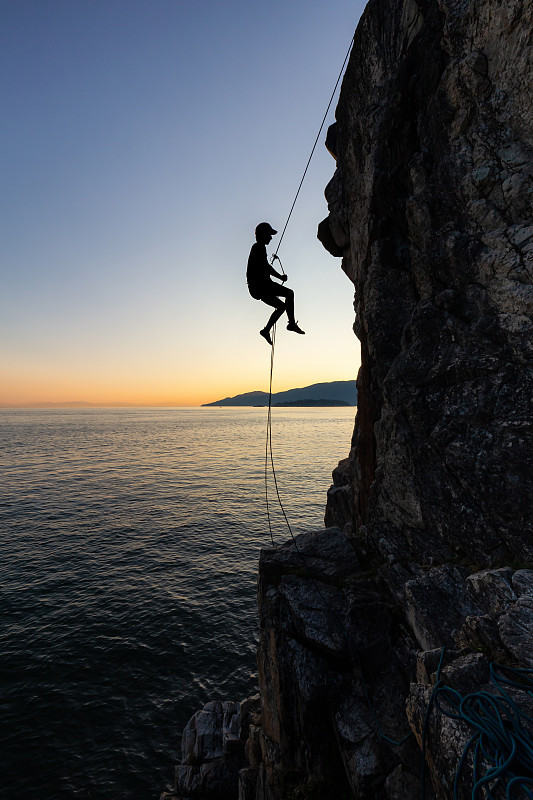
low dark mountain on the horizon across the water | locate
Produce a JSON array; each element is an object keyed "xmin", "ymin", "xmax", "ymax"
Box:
[{"xmin": 203, "ymin": 381, "xmax": 357, "ymax": 406}]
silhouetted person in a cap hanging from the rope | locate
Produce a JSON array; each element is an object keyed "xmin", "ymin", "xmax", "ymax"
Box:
[{"xmin": 246, "ymin": 222, "xmax": 305, "ymax": 344}]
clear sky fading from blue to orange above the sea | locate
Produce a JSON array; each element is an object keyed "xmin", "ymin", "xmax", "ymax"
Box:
[{"xmin": 0, "ymin": 0, "xmax": 364, "ymax": 405}]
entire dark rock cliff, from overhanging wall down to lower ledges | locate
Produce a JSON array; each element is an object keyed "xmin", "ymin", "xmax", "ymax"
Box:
[{"xmin": 164, "ymin": 0, "xmax": 533, "ymax": 800}]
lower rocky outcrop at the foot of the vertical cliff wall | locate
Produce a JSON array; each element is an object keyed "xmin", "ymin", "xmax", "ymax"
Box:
[{"xmin": 239, "ymin": 528, "xmax": 533, "ymax": 800}]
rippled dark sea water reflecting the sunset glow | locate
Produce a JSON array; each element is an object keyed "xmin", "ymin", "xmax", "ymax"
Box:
[{"xmin": 0, "ymin": 408, "xmax": 355, "ymax": 800}]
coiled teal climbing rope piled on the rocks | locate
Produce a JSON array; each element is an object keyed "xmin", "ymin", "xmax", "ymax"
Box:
[{"xmin": 422, "ymin": 647, "xmax": 533, "ymax": 800}]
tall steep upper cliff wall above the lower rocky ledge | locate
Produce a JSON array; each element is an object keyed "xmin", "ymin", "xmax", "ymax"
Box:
[{"xmin": 319, "ymin": 0, "xmax": 533, "ymax": 565}]
